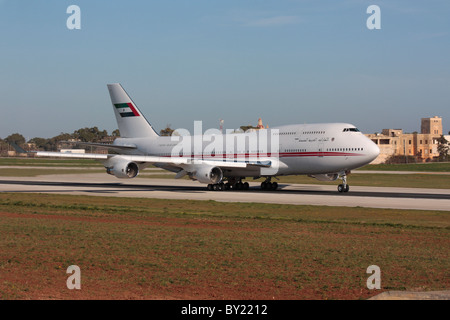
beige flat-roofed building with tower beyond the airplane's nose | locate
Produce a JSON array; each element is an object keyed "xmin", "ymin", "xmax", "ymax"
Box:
[{"xmin": 366, "ymin": 116, "xmax": 442, "ymax": 164}]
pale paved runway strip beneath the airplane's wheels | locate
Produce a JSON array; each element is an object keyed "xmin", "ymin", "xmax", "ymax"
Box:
[{"xmin": 0, "ymin": 173, "xmax": 450, "ymax": 211}]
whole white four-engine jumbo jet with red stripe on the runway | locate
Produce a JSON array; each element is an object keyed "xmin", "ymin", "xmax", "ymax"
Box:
[{"xmin": 37, "ymin": 83, "xmax": 380, "ymax": 192}]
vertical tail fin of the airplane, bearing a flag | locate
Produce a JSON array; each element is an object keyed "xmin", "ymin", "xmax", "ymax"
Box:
[{"xmin": 107, "ymin": 83, "xmax": 158, "ymax": 138}]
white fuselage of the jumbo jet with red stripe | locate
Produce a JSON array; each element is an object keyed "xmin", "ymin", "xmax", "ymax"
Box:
[{"xmin": 115, "ymin": 123, "xmax": 379, "ymax": 177}]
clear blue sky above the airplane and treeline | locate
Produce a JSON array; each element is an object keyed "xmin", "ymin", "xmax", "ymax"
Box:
[{"xmin": 0, "ymin": 0, "xmax": 450, "ymax": 139}]
